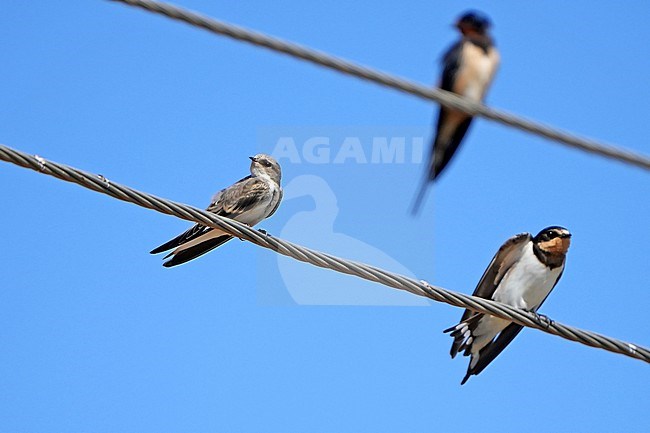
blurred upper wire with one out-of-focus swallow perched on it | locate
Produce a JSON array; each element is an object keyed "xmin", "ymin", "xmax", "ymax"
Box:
[{"xmin": 111, "ymin": 0, "xmax": 650, "ymax": 170}]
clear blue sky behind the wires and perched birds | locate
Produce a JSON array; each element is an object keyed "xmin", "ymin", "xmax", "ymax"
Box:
[{"xmin": 0, "ymin": 0, "xmax": 650, "ymax": 432}]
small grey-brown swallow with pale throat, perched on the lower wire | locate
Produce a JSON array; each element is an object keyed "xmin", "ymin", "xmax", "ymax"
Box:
[{"xmin": 151, "ymin": 153, "xmax": 282, "ymax": 268}]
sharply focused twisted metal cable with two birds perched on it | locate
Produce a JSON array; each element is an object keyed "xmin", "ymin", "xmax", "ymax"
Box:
[{"xmin": 0, "ymin": 144, "xmax": 650, "ymax": 363}]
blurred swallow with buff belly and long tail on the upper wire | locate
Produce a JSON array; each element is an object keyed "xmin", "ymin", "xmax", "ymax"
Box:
[{"xmin": 413, "ymin": 11, "xmax": 499, "ymax": 214}]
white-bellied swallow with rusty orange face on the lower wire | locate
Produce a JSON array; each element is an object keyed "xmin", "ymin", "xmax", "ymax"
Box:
[{"xmin": 444, "ymin": 226, "xmax": 571, "ymax": 385}]
